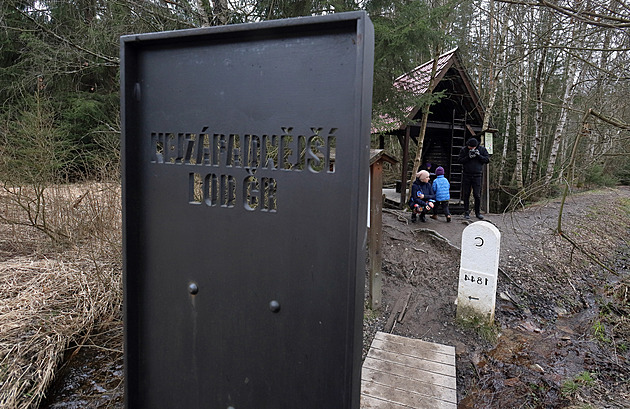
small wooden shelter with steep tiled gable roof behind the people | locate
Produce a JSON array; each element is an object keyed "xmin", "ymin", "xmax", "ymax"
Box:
[{"xmin": 373, "ymin": 48, "xmax": 495, "ymax": 211}]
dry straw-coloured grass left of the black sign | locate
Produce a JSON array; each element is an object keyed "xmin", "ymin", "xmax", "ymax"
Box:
[{"xmin": 0, "ymin": 184, "xmax": 122, "ymax": 409}]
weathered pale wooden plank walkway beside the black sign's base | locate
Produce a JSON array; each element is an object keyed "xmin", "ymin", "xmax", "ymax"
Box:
[{"xmin": 361, "ymin": 332, "xmax": 457, "ymax": 409}]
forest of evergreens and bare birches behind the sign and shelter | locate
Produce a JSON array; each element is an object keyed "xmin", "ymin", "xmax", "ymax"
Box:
[{"xmin": 0, "ymin": 0, "xmax": 630, "ymax": 184}]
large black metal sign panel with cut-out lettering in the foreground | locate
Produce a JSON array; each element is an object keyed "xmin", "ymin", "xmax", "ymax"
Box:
[{"xmin": 121, "ymin": 12, "xmax": 373, "ymax": 409}]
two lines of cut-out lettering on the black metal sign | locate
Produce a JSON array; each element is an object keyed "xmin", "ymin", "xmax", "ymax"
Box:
[{"xmin": 150, "ymin": 127, "xmax": 337, "ymax": 213}]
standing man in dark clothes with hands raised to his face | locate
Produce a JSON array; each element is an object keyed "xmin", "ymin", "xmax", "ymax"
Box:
[{"xmin": 459, "ymin": 138, "xmax": 490, "ymax": 220}]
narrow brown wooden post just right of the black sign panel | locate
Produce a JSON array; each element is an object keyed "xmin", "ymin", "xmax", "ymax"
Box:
[{"xmin": 368, "ymin": 161, "xmax": 383, "ymax": 311}]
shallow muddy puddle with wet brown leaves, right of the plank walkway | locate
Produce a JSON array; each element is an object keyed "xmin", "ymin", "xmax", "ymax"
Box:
[{"xmin": 458, "ymin": 280, "xmax": 630, "ymax": 409}]
